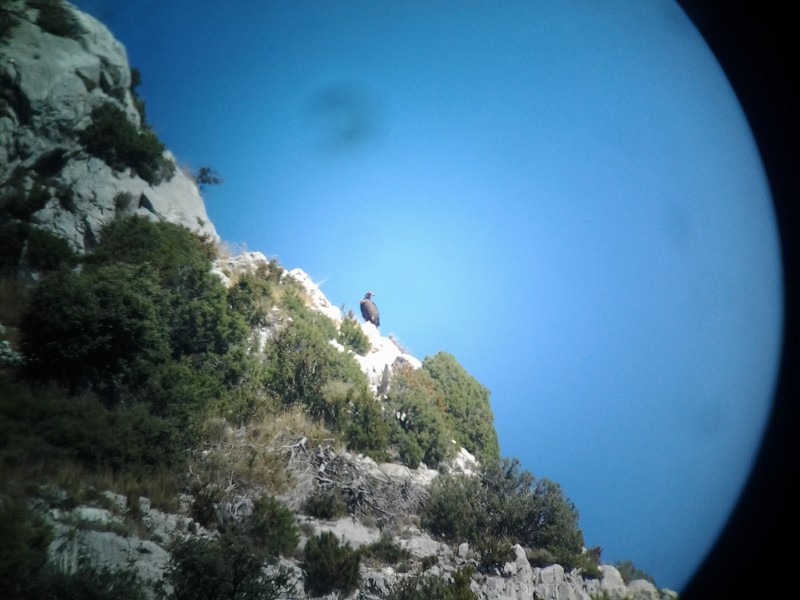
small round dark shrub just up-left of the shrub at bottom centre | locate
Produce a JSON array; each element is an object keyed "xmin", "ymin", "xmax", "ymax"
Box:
[{"xmin": 247, "ymin": 496, "xmax": 300, "ymax": 560}]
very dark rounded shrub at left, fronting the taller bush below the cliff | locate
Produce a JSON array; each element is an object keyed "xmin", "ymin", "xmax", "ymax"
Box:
[{"xmin": 21, "ymin": 264, "xmax": 170, "ymax": 394}]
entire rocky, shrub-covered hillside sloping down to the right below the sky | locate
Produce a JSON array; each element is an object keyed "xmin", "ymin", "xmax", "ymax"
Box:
[{"xmin": 0, "ymin": 0, "xmax": 674, "ymax": 600}]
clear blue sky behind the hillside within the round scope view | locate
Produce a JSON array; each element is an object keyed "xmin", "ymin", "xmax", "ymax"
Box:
[{"xmin": 69, "ymin": 0, "xmax": 783, "ymax": 590}]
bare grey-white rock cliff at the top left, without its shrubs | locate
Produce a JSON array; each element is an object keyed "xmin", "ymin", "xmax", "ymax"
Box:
[{"xmin": 0, "ymin": 1, "xmax": 219, "ymax": 252}]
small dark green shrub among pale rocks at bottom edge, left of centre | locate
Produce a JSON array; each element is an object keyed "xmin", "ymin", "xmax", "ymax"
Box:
[{"xmin": 302, "ymin": 531, "xmax": 361, "ymax": 596}]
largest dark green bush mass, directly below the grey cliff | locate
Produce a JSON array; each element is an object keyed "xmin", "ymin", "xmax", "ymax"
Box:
[{"xmin": 13, "ymin": 217, "xmax": 264, "ymax": 469}]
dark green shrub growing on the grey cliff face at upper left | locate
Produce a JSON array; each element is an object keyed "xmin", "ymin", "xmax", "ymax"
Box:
[{"xmin": 78, "ymin": 102, "xmax": 175, "ymax": 185}]
